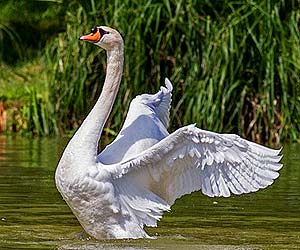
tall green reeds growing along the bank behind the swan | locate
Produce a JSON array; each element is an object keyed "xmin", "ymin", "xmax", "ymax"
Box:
[{"xmin": 0, "ymin": 0, "xmax": 300, "ymax": 143}]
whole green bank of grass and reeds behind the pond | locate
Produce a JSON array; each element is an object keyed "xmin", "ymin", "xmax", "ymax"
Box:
[{"xmin": 0, "ymin": 0, "xmax": 300, "ymax": 144}]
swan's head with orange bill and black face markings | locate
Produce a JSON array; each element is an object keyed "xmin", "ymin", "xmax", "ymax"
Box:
[{"xmin": 79, "ymin": 26, "xmax": 123, "ymax": 51}]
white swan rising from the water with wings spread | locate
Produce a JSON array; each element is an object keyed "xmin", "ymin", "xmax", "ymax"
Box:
[{"xmin": 55, "ymin": 26, "xmax": 282, "ymax": 239}]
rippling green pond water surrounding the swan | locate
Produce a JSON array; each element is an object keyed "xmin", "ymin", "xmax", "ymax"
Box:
[{"xmin": 0, "ymin": 136, "xmax": 300, "ymax": 250}]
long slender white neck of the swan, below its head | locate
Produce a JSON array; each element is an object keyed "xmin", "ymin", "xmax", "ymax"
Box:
[{"xmin": 68, "ymin": 44, "xmax": 124, "ymax": 161}]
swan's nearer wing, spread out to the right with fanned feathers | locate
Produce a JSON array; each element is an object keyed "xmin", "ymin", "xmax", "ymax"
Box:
[{"xmin": 112, "ymin": 125, "xmax": 282, "ymax": 205}]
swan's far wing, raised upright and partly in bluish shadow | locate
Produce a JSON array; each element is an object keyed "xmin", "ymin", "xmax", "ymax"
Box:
[{"xmin": 97, "ymin": 78, "xmax": 172, "ymax": 164}]
